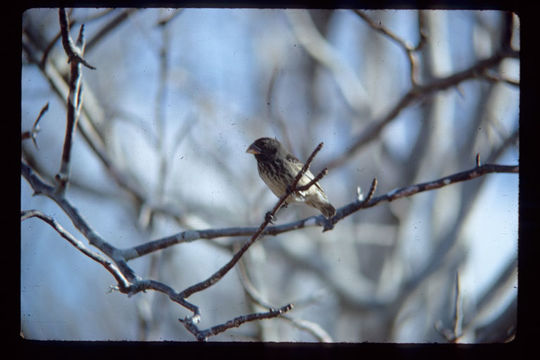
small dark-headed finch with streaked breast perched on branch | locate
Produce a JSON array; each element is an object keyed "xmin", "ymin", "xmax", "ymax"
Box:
[{"xmin": 246, "ymin": 138, "xmax": 336, "ymax": 218}]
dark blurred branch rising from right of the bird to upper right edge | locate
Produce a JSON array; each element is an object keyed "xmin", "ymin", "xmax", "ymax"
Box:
[{"xmin": 328, "ymin": 49, "xmax": 519, "ymax": 169}]
